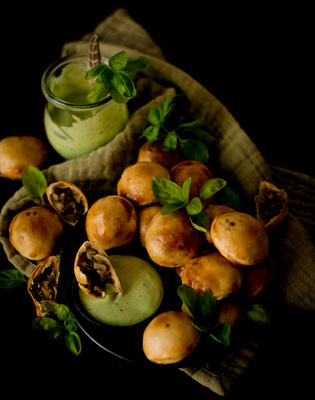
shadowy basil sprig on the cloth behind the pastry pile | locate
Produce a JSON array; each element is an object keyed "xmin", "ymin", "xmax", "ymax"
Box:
[{"xmin": 141, "ymin": 95, "xmax": 215, "ymax": 164}]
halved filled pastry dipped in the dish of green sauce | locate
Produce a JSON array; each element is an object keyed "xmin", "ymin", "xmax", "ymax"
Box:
[{"xmin": 74, "ymin": 241, "xmax": 123, "ymax": 299}]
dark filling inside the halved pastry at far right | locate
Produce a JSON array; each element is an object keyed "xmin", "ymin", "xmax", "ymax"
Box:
[{"xmin": 259, "ymin": 189, "xmax": 285, "ymax": 223}]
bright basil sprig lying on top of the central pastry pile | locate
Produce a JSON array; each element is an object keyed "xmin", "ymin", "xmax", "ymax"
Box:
[{"xmin": 152, "ymin": 177, "xmax": 226, "ymax": 232}]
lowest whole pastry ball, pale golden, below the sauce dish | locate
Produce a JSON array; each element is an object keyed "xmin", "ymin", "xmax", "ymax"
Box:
[{"xmin": 142, "ymin": 311, "xmax": 201, "ymax": 364}]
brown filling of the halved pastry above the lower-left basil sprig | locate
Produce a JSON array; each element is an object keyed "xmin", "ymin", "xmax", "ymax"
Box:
[{"xmin": 32, "ymin": 265, "xmax": 58, "ymax": 302}]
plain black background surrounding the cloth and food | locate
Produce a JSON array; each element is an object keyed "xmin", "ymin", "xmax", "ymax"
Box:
[{"xmin": 0, "ymin": 1, "xmax": 314, "ymax": 399}]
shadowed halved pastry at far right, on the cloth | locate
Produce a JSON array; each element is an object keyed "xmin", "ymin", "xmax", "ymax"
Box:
[{"xmin": 255, "ymin": 181, "xmax": 288, "ymax": 229}]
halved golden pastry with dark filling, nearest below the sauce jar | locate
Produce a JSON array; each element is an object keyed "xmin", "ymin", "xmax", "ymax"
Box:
[{"xmin": 46, "ymin": 181, "xmax": 88, "ymax": 226}]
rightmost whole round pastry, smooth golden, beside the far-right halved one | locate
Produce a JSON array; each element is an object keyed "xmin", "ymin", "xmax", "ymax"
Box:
[{"xmin": 210, "ymin": 211, "xmax": 269, "ymax": 265}]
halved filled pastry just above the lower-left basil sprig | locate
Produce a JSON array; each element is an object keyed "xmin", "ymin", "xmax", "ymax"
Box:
[{"xmin": 27, "ymin": 256, "xmax": 60, "ymax": 317}]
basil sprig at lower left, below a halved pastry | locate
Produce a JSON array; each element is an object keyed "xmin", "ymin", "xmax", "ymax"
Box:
[{"xmin": 32, "ymin": 301, "xmax": 82, "ymax": 356}]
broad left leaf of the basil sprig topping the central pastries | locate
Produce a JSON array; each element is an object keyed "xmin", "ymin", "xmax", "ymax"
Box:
[{"xmin": 152, "ymin": 176, "xmax": 185, "ymax": 206}]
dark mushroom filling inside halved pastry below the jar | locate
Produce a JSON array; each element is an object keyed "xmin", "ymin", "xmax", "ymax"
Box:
[{"xmin": 52, "ymin": 187, "xmax": 84, "ymax": 222}]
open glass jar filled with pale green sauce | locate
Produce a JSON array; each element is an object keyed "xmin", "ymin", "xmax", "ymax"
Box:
[{"xmin": 42, "ymin": 56, "xmax": 129, "ymax": 159}]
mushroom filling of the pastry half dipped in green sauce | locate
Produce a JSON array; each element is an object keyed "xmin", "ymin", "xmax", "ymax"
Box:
[{"xmin": 79, "ymin": 248, "xmax": 113, "ymax": 296}]
